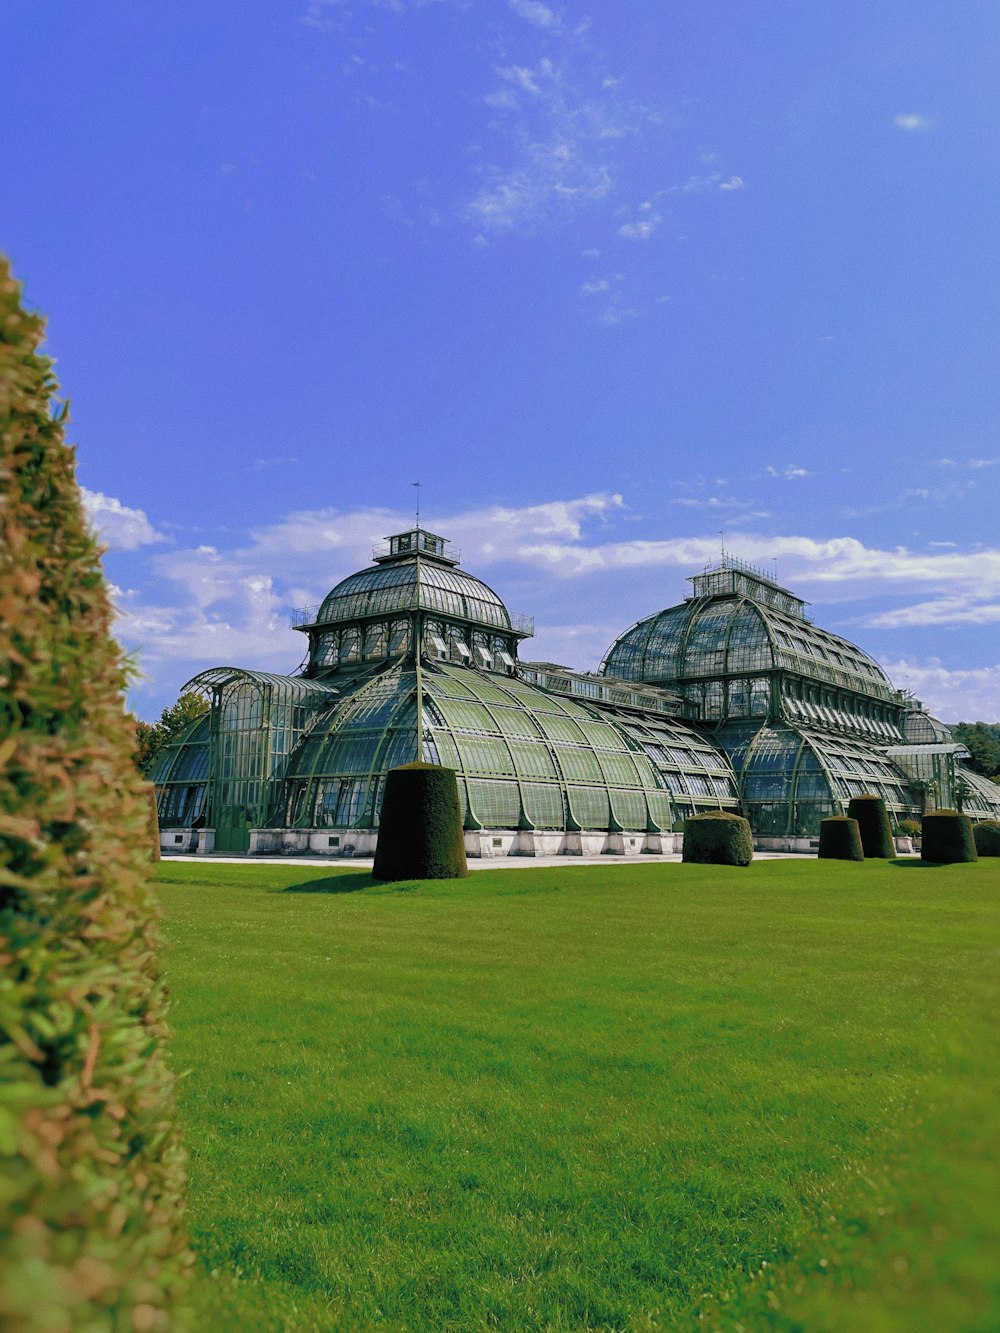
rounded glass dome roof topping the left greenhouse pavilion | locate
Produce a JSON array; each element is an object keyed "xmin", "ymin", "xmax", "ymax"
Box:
[{"xmin": 315, "ymin": 559, "xmax": 511, "ymax": 629}]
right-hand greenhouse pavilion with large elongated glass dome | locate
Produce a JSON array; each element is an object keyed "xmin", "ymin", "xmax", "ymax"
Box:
[{"xmin": 601, "ymin": 557, "xmax": 997, "ymax": 837}]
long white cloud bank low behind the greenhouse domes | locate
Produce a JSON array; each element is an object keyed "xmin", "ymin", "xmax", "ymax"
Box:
[{"xmin": 119, "ymin": 492, "xmax": 1000, "ymax": 717}]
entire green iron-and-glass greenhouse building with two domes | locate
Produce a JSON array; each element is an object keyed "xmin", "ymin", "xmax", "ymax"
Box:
[{"xmin": 152, "ymin": 528, "xmax": 1000, "ymax": 856}]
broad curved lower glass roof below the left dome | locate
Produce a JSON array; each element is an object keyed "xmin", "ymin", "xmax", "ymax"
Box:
[{"xmin": 280, "ymin": 663, "xmax": 736, "ymax": 830}]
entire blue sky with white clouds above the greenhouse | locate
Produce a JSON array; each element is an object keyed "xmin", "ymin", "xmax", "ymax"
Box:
[{"xmin": 0, "ymin": 0, "xmax": 1000, "ymax": 721}]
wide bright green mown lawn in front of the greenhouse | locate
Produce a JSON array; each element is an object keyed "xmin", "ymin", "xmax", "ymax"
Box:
[{"xmin": 160, "ymin": 858, "xmax": 1000, "ymax": 1333}]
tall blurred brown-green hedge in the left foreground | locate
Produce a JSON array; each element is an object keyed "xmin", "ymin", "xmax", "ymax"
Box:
[{"xmin": 0, "ymin": 260, "xmax": 188, "ymax": 1333}]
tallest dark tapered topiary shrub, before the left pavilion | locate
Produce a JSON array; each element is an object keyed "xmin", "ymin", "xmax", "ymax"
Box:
[{"xmin": 372, "ymin": 762, "xmax": 469, "ymax": 884}]
